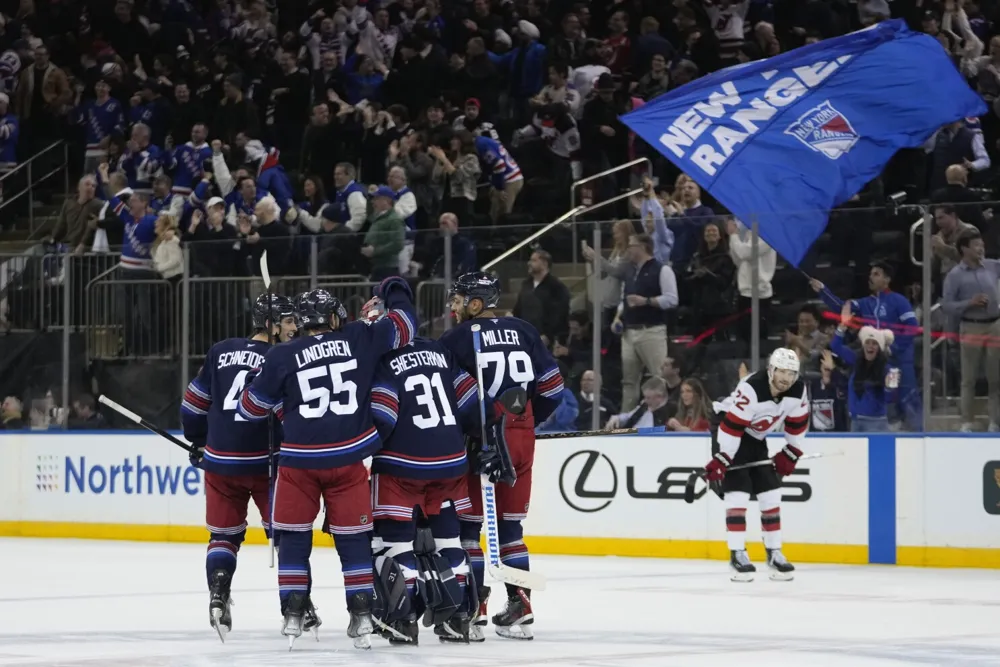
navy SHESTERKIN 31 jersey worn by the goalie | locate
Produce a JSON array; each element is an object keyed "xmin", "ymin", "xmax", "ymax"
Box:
[{"xmin": 371, "ymin": 338, "xmax": 479, "ymax": 479}]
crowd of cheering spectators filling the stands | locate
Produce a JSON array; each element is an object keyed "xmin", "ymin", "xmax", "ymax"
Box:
[{"xmin": 0, "ymin": 0, "xmax": 1000, "ymax": 430}]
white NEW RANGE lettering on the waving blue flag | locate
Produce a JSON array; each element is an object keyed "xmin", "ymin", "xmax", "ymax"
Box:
[{"xmin": 660, "ymin": 56, "xmax": 851, "ymax": 176}]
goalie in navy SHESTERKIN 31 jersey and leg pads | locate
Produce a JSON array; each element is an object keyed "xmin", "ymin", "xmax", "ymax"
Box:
[{"xmin": 362, "ymin": 298, "xmax": 479, "ymax": 643}]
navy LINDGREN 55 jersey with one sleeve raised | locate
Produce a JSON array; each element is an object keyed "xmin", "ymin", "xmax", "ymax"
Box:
[{"xmin": 239, "ymin": 297, "xmax": 416, "ymax": 469}]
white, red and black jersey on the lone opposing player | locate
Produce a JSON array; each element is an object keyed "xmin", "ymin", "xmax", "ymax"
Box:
[{"xmin": 717, "ymin": 371, "xmax": 809, "ymax": 457}]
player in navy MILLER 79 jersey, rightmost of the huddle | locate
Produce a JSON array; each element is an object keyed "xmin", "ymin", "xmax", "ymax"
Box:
[{"xmin": 441, "ymin": 271, "xmax": 563, "ymax": 641}]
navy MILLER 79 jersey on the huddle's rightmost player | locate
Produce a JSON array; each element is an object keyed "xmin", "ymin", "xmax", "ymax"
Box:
[{"xmin": 441, "ymin": 317, "xmax": 563, "ymax": 424}]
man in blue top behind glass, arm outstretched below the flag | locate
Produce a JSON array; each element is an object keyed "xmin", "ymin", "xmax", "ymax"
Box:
[{"xmin": 809, "ymin": 261, "xmax": 923, "ymax": 431}]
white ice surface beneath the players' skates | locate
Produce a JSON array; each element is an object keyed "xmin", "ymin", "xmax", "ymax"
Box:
[{"xmin": 0, "ymin": 538, "xmax": 1000, "ymax": 667}]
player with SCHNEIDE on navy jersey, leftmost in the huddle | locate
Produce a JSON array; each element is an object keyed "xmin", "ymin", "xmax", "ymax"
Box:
[{"xmin": 181, "ymin": 294, "xmax": 295, "ymax": 641}]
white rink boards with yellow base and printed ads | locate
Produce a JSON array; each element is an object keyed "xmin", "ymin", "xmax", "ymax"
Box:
[{"xmin": 0, "ymin": 432, "xmax": 1000, "ymax": 567}]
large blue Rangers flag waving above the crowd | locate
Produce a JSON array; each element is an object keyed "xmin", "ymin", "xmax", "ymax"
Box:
[{"xmin": 622, "ymin": 20, "xmax": 986, "ymax": 266}]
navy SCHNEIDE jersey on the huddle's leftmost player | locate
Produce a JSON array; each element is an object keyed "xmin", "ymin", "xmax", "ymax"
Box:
[{"xmin": 181, "ymin": 338, "xmax": 281, "ymax": 475}]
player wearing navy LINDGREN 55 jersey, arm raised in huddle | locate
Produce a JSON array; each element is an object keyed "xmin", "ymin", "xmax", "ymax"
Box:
[{"xmin": 239, "ymin": 278, "xmax": 416, "ymax": 648}]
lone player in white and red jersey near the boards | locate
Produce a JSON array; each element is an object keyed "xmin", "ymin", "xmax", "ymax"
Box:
[{"xmin": 705, "ymin": 348, "xmax": 809, "ymax": 581}]
